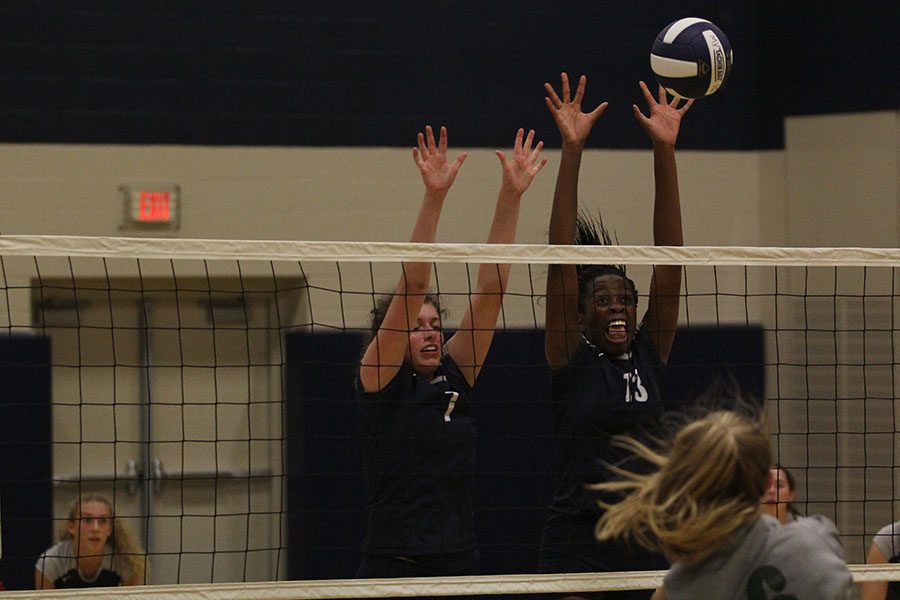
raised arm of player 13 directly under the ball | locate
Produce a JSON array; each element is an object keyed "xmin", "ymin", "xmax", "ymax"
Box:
[{"xmin": 632, "ymin": 81, "xmax": 694, "ymax": 362}]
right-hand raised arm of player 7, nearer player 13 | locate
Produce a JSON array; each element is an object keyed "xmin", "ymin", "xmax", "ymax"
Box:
[{"xmin": 446, "ymin": 129, "xmax": 547, "ymax": 385}]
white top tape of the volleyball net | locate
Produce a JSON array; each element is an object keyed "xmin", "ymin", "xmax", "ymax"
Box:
[{"xmin": 0, "ymin": 235, "xmax": 900, "ymax": 267}]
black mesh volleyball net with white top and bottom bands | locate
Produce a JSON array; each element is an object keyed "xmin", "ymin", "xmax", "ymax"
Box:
[{"xmin": 0, "ymin": 236, "xmax": 900, "ymax": 598}]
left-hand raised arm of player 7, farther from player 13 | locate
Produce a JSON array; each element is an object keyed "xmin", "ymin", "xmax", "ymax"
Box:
[{"xmin": 359, "ymin": 127, "xmax": 466, "ymax": 392}]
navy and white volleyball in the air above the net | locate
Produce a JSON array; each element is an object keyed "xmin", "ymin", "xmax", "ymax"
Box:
[{"xmin": 650, "ymin": 17, "xmax": 732, "ymax": 98}]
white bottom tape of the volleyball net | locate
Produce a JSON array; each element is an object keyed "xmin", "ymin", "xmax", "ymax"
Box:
[{"xmin": 3, "ymin": 564, "xmax": 900, "ymax": 600}]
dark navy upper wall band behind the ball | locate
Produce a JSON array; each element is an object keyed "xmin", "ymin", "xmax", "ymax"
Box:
[{"xmin": 0, "ymin": 0, "xmax": 900, "ymax": 149}]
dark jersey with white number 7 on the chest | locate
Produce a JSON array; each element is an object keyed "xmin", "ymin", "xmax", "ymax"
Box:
[{"xmin": 357, "ymin": 356, "xmax": 475, "ymax": 568}]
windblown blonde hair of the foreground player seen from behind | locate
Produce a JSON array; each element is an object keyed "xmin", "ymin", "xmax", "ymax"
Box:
[{"xmin": 596, "ymin": 410, "xmax": 772, "ymax": 566}]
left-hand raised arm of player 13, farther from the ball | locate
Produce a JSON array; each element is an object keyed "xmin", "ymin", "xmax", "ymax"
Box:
[{"xmin": 544, "ymin": 73, "xmax": 609, "ymax": 369}]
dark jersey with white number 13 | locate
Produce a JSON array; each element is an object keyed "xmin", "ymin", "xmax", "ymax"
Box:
[{"xmin": 550, "ymin": 328, "xmax": 663, "ymax": 521}]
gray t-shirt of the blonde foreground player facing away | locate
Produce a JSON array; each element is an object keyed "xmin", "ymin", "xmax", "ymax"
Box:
[{"xmin": 663, "ymin": 515, "xmax": 853, "ymax": 600}]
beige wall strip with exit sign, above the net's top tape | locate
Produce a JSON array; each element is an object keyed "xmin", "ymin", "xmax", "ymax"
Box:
[{"xmin": 0, "ymin": 112, "xmax": 900, "ymax": 246}]
